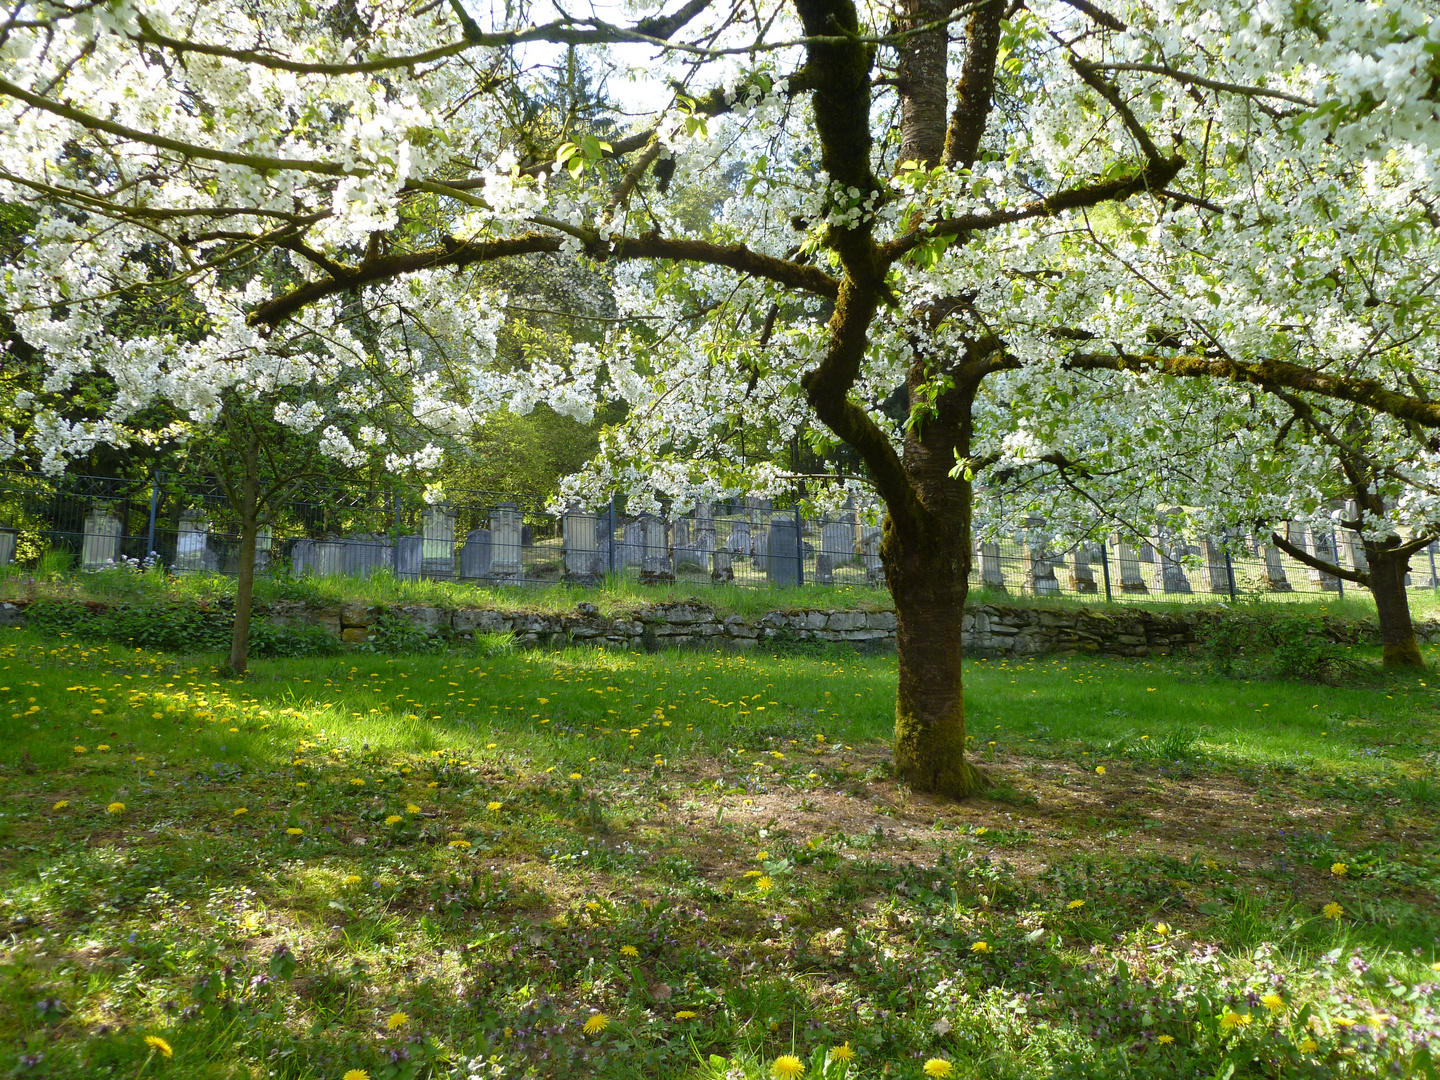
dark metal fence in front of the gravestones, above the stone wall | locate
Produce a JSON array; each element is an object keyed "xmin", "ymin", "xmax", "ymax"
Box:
[{"xmin": 0, "ymin": 471, "xmax": 1440, "ymax": 602}]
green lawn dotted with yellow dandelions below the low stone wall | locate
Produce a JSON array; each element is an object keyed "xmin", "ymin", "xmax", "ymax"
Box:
[{"xmin": 0, "ymin": 629, "xmax": 1440, "ymax": 1080}]
